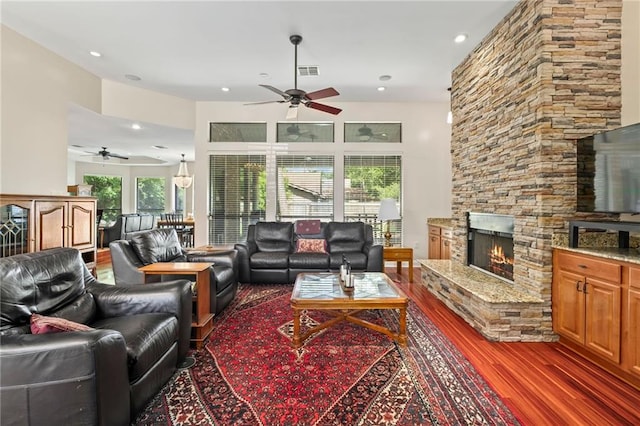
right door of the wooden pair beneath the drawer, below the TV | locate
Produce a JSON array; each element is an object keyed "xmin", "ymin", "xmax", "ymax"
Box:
[{"xmin": 584, "ymin": 277, "xmax": 622, "ymax": 363}]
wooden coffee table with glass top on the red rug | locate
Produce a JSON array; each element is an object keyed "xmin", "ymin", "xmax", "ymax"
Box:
[{"xmin": 291, "ymin": 272, "xmax": 409, "ymax": 348}]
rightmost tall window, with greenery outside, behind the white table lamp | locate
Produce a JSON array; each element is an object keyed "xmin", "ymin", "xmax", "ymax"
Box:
[{"xmin": 344, "ymin": 155, "xmax": 402, "ymax": 245}]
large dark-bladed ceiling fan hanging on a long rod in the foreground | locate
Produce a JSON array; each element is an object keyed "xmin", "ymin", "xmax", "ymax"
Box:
[{"xmin": 246, "ymin": 35, "xmax": 342, "ymax": 119}]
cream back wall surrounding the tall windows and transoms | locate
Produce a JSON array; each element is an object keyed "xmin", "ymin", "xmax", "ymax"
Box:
[{"xmin": 195, "ymin": 101, "xmax": 451, "ymax": 258}]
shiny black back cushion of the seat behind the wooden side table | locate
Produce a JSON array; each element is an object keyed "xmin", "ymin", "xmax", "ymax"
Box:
[{"xmin": 129, "ymin": 228, "xmax": 186, "ymax": 265}]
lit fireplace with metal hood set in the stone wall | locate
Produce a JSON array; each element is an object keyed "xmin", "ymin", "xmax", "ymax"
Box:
[{"xmin": 467, "ymin": 212, "xmax": 514, "ymax": 282}]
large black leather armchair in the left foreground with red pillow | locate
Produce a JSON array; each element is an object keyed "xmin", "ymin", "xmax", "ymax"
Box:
[{"xmin": 0, "ymin": 248, "xmax": 192, "ymax": 425}]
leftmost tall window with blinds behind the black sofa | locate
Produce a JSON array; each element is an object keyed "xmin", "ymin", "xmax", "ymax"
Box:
[{"xmin": 209, "ymin": 155, "xmax": 267, "ymax": 244}]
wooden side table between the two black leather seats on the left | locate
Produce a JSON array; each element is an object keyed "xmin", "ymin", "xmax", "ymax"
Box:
[{"xmin": 138, "ymin": 262, "xmax": 213, "ymax": 349}]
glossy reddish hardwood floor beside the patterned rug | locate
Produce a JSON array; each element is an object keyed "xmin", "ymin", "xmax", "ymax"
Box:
[{"xmin": 98, "ymin": 258, "xmax": 640, "ymax": 426}]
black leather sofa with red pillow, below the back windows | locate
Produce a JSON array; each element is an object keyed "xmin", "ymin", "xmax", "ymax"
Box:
[{"xmin": 235, "ymin": 222, "xmax": 384, "ymax": 284}]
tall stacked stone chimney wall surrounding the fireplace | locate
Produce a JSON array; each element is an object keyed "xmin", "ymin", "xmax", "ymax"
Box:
[{"xmin": 451, "ymin": 0, "xmax": 622, "ymax": 309}]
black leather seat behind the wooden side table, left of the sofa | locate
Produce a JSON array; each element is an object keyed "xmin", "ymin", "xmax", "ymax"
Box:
[{"xmin": 109, "ymin": 228, "xmax": 238, "ymax": 314}]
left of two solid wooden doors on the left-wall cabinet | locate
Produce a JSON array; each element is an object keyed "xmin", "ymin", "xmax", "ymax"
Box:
[{"xmin": 35, "ymin": 201, "xmax": 67, "ymax": 251}]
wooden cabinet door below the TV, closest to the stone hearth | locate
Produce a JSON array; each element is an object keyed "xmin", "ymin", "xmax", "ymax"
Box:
[{"xmin": 553, "ymin": 269, "xmax": 585, "ymax": 344}]
